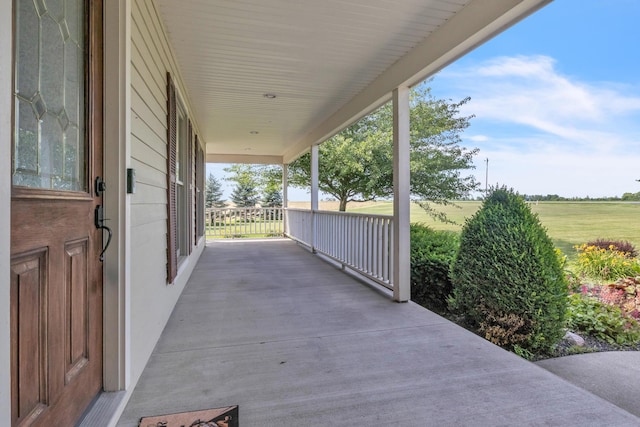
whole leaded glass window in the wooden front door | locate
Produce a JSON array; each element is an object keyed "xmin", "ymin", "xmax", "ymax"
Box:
[{"xmin": 13, "ymin": 0, "xmax": 88, "ymax": 191}]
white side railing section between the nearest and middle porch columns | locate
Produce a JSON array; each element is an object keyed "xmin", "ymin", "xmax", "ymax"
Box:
[{"xmin": 285, "ymin": 209, "xmax": 393, "ymax": 289}]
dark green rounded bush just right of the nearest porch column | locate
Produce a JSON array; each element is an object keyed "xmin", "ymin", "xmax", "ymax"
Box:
[{"xmin": 411, "ymin": 224, "xmax": 459, "ymax": 313}]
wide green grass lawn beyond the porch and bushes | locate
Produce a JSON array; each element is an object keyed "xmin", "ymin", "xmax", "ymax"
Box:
[{"xmin": 347, "ymin": 202, "xmax": 640, "ymax": 258}]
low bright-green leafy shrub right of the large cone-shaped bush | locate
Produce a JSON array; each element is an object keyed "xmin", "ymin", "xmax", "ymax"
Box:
[{"xmin": 567, "ymin": 294, "xmax": 640, "ymax": 345}]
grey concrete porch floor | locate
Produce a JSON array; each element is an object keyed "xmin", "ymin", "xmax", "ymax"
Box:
[{"xmin": 118, "ymin": 240, "xmax": 640, "ymax": 427}]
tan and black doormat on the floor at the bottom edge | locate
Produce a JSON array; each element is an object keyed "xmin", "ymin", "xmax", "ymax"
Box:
[{"xmin": 139, "ymin": 406, "xmax": 240, "ymax": 427}]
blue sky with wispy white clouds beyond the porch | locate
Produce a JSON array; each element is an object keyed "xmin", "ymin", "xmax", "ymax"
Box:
[{"xmin": 208, "ymin": 0, "xmax": 640, "ymax": 200}]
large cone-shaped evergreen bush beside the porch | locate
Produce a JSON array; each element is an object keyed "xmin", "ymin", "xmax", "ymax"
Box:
[{"xmin": 449, "ymin": 187, "xmax": 567, "ymax": 355}]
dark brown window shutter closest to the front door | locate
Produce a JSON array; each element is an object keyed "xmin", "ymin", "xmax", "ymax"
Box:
[{"xmin": 167, "ymin": 73, "xmax": 178, "ymax": 283}]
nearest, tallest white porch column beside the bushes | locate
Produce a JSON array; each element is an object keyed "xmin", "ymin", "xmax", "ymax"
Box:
[{"xmin": 393, "ymin": 87, "xmax": 411, "ymax": 302}]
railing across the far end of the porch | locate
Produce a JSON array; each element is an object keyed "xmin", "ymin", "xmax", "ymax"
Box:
[{"xmin": 205, "ymin": 208, "xmax": 284, "ymax": 237}]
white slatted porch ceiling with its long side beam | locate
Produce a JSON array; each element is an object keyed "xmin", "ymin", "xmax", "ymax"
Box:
[{"xmin": 156, "ymin": 0, "xmax": 550, "ymax": 163}]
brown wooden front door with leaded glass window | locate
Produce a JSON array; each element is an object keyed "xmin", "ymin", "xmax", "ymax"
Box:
[{"xmin": 10, "ymin": 0, "xmax": 103, "ymax": 426}]
